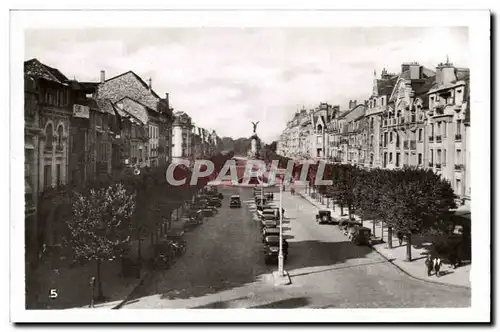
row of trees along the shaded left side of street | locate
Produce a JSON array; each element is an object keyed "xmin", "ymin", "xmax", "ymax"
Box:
[{"xmin": 35, "ymin": 153, "xmax": 233, "ymax": 302}]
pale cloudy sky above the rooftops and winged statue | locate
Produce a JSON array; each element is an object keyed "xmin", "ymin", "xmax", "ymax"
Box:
[{"xmin": 25, "ymin": 27, "xmax": 469, "ymax": 142}]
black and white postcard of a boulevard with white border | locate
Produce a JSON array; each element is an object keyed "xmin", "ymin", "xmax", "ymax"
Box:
[{"xmin": 10, "ymin": 11, "xmax": 491, "ymax": 322}]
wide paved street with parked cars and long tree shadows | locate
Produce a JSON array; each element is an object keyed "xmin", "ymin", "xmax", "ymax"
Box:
[{"xmin": 124, "ymin": 188, "xmax": 470, "ymax": 308}]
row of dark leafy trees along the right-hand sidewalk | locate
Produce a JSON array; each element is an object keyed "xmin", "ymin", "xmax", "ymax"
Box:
[{"xmin": 294, "ymin": 164, "xmax": 470, "ymax": 260}]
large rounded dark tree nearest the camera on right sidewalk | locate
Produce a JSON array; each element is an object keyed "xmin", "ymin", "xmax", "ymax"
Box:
[{"xmin": 387, "ymin": 167, "xmax": 456, "ymax": 261}]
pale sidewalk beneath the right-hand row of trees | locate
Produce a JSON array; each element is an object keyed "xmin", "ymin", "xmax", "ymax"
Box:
[{"xmin": 296, "ymin": 188, "xmax": 471, "ymax": 288}]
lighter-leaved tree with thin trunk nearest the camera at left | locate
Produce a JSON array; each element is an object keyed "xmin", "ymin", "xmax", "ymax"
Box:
[{"xmin": 66, "ymin": 184, "xmax": 135, "ymax": 300}]
